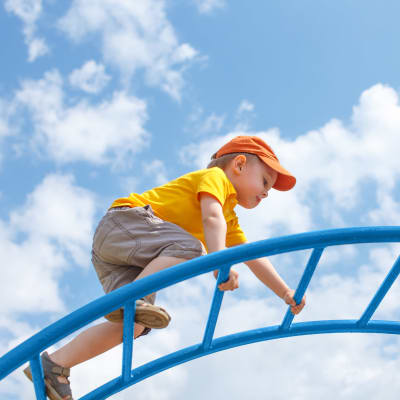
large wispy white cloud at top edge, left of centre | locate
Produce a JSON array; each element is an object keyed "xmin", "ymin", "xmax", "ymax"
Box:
[{"xmin": 59, "ymin": 0, "xmax": 197, "ymax": 100}]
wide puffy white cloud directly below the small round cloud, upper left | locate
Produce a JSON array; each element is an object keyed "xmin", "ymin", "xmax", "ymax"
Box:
[{"xmin": 15, "ymin": 71, "xmax": 148, "ymax": 165}]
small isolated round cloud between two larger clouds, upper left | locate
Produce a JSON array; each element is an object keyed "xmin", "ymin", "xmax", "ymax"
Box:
[{"xmin": 69, "ymin": 60, "xmax": 111, "ymax": 93}]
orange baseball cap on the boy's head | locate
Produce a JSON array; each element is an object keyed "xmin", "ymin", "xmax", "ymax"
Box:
[{"xmin": 216, "ymin": 136, "xmax": 296, "ymax": 191}]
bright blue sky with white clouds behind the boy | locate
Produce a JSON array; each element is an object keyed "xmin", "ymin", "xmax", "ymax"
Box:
[{"xmin": 0, "ymin": 0, "xmax": 400, "ymax": 400}]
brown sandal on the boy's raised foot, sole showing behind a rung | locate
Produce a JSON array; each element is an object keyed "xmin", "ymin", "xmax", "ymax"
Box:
[{"xmin": 104, "ymin": 300, "xmax": 171, "ymax": 329}]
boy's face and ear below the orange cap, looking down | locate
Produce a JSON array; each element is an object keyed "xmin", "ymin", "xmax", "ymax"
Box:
[{"xmin": 226, "ymin": 155, "xmax": 278, "ymax": 208}]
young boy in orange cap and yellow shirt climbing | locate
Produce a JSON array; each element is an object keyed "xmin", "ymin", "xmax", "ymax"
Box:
[{"xmin": 24, "ymin": 136, "xmax": 305, "ymax": 400}]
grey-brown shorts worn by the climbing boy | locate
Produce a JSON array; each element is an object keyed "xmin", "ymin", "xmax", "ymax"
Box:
[{"xmin": 92, "ymin": 205, "xmax": 206, "ymax": 304}]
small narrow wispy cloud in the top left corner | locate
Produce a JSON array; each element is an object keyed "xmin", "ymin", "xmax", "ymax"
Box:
[{"xmin": 4, "ymin": 0, "xmax": 49, "ymax": 62}]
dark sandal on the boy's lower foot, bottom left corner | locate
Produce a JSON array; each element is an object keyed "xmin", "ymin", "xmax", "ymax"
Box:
[{"xmin": 24, "ymin": 352, "xmax": 73, "ymax": 400}]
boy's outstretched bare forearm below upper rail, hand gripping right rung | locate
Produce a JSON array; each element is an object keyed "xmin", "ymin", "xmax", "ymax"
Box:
[{"xmin": 245, "ymin": 257, "xmax": 306, "ymax": 314}]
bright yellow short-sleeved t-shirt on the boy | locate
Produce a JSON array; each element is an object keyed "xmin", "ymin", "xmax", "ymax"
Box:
[{"xmin": 111, "ymin": 167, "xmax": 247, "ymax": 247}]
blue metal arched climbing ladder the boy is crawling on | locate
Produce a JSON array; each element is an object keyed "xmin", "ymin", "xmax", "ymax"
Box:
[{"xmin": 0, "ymin": 226, "xmax": 400, "ymax": 400}]
